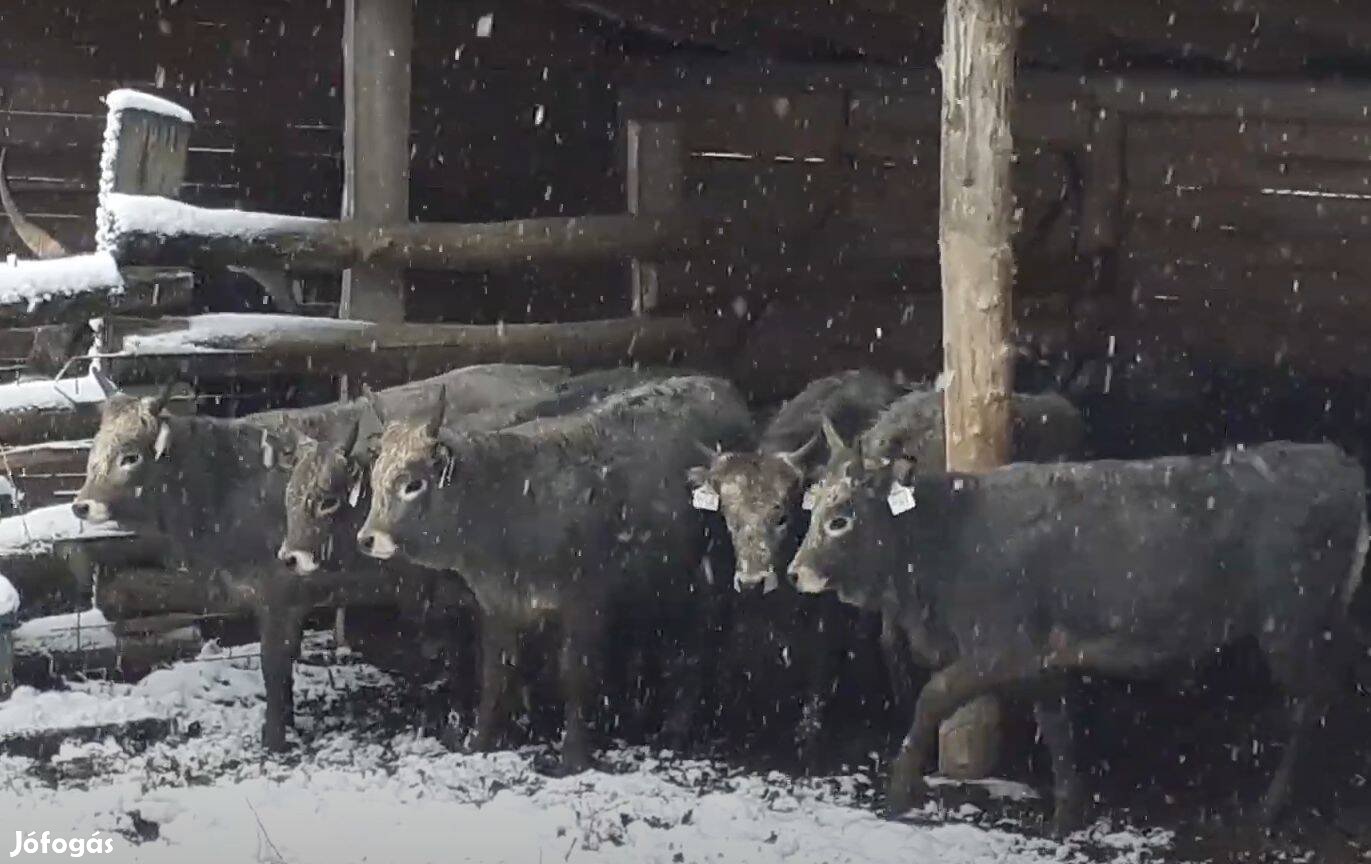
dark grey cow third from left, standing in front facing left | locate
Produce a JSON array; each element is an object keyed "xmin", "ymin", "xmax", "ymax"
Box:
[{"xmin": 358, "ymin": 376, "xmax": 753, "ymax": 772}]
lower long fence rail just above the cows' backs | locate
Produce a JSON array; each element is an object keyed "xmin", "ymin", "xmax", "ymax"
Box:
[{"xmin": 106, "ymin": 314, "xmax": 740, "ymax": 384}]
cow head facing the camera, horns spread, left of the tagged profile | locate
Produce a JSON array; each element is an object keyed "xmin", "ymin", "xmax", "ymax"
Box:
[{"xmin": 688, "ymin": 436, "xmax": 818, "ymax": 591}]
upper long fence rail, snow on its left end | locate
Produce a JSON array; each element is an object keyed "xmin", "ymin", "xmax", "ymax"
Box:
[{"xmin": 101, "ymin": 193, "xmax": 710, "ymax": 272}]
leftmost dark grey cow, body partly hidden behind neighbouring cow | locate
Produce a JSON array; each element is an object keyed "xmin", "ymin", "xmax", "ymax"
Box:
[{"xmin": 71, "ymin": 365, "xmax": 569, "ymax": 750}]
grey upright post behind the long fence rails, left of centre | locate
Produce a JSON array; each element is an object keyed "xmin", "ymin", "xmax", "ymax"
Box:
[{"xmin": 339, "ymin": 0, "xmax": 414, "ymax": 322}]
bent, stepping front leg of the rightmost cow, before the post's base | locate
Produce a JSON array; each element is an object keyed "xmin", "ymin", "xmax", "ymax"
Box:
[{"xmin": 886, "ymin": 651, "xmax": 1042, "ymax": 816}]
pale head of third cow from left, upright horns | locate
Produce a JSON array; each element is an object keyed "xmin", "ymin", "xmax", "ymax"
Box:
[{"xmin": 356, "ymin": 389, "xmax": 452, "ymax": 560}]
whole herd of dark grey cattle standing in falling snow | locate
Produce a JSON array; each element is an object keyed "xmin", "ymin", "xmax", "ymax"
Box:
[{"xmin": 64, "ymin": 365, "xmax": 1367, "ymax": 830}]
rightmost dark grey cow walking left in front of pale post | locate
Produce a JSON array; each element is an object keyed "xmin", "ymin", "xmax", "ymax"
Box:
[{"xmin": 788, "ymin": 442, "xmax": 1367, "ymax": 831}]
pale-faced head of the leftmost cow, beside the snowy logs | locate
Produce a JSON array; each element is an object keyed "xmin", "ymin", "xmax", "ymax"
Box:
[{"xmin": 71, "ymin": 379, "xmax": 171, "ymax": 524}]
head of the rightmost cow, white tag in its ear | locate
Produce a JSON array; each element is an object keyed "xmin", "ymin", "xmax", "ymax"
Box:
[{"xmin": 787, "ymin": 427, "xmax": 913, "ymax": 606}]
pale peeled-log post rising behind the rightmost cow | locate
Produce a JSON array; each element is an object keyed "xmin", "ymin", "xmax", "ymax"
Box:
[{"xmin": 938, "ymin": 0, "xmax": 1019, "ymax": 778}]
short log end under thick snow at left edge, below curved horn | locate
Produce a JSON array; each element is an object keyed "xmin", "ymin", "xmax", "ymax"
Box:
[{"xmin": 0, "ymin": 252, "xmax": 195, "ymax": 326}]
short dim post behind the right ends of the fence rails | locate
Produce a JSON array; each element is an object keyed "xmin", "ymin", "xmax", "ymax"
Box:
[{"xmin": 625, "ymin": 121, "xmax": 686, "ymax": 315}]
